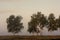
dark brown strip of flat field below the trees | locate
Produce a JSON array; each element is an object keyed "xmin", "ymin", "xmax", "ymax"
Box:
[{"xmin": 0, "ymin": 35, "xmax": 60, "ymax": 40}]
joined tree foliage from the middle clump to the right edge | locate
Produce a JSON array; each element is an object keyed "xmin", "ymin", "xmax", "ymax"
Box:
[{"xmin": 28, "ymin": 12, "xmax": 60, "ymax": 33}]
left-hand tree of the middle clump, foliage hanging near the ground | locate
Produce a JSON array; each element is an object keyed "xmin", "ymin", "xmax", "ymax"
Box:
[{"xmin": 28, "ymin": 14, "xmax": 39, "ymax": 34}]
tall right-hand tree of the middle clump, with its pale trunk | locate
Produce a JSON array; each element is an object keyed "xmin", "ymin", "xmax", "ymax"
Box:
[{"xmin": 37, "ymin": 12, "xmax": 48, "ymax": 35}]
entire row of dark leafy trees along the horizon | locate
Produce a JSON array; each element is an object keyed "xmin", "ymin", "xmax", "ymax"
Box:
[{"xmin": 7, "ymin": 12, "xmax": 60, "ymax": 34}]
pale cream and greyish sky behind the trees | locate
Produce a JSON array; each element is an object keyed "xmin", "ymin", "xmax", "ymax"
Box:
[{"xmin": 0, "ymin": 0, "xmax": 60, "ymax": 35}]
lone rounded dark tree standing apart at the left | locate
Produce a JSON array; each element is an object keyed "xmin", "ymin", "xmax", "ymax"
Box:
[{"xmin": 7, "ymin": 15, "xmax": 24, "ymax": 34}]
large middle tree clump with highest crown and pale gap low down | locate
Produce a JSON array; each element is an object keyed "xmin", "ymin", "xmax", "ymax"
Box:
[{"xmin": 28, "ymin": 12, "xmax": 47, "ymax": 34}]
